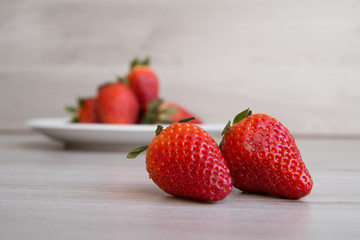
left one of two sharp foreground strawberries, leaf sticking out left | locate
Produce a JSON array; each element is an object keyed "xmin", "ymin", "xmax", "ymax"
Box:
[{"xmin": 128, "ymin": 119, "xmax": 232, "ymax": 201}]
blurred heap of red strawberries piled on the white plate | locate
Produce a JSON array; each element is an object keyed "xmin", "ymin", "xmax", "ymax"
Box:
[{"xmin": 67, "ymin": 58, "xmax": 201, "ymax": 124}]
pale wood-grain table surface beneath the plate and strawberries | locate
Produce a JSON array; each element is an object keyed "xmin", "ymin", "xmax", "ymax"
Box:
[{"xmin": 0, "ymin": 134, "xmax": 360, "ymax": 240}]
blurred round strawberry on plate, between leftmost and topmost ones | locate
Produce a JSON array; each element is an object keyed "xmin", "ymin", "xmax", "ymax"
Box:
[{"xmin": 96, "ymin": 81, "xmax": 140, "ymax": 124}]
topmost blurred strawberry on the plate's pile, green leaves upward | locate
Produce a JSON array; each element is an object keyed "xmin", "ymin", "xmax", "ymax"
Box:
[{"xmin": 127, "ymin": 58, "xmax": 159, "ymax": 111}]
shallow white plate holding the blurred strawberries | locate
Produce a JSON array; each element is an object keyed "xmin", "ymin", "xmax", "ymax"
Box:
[{"xmin": 27, "ymin": 118, "xmax": 224, "ymax": 146}]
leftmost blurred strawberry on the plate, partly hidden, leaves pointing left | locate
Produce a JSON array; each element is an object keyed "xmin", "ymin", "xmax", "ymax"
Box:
[{"xmin": 66, "ymin": 97, "xmax": 99, "ymax": 123}]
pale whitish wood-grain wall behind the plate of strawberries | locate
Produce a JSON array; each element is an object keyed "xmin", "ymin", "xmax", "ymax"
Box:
[{"xmin": 0, "ymin": 0, "xmax": 360, "ymax": 135}]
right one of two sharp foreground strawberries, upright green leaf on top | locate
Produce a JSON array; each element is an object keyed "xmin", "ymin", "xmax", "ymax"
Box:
[{"xmin": 221, "ymin": 109, "xmax": 313, "ymax": 199}]
